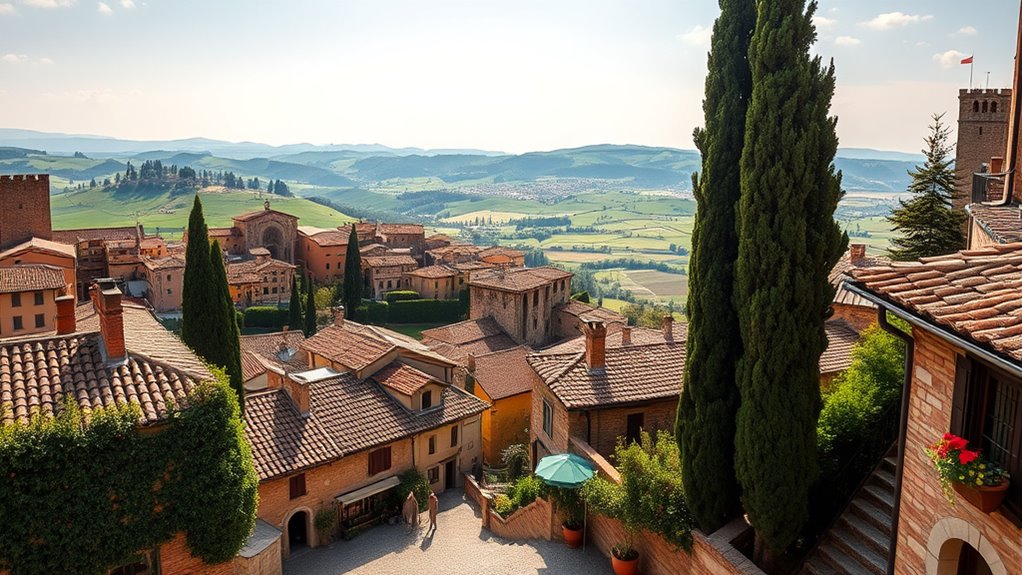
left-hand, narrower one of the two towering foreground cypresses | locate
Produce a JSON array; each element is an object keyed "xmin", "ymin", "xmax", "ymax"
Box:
[{"xmin": 677, "ymin": 0, "xmax": 756, "ymax": 532}]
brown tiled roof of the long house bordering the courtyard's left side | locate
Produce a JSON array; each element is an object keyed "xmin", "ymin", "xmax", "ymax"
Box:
[{"xmin": 245, "ymin": 373, "xmax": 487, "ymax": 480}]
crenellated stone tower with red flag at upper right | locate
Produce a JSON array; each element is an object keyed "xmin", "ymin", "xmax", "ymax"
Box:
[{"xmin": 955, "ymin": 88, "xmax": 1012, "ymax": 209}]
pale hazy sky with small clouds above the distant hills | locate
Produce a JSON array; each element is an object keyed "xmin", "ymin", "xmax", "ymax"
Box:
[{"xmin": 0, "ymin": 0, "xmax": 1019, "ymax": 153}]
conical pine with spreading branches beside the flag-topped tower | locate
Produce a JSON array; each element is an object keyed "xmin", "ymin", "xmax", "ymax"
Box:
[{"xmin": 887, "ymin": 113, "xmax": 966, "ymax": 259}]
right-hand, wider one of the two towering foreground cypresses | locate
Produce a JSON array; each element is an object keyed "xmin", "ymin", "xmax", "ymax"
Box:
[{"xmin": 735, "ymin": 0, "xmax": 847, "ymax": 570}]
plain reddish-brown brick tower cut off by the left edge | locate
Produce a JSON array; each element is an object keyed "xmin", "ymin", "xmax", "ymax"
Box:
[{"xmin": 0, "ymin": 174, "xmax": 53, "ymax": 250}]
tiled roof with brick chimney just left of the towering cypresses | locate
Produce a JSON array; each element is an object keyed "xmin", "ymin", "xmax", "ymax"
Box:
[{"xmin": 528, "ymin": 340, "xmax": 685, "ymax": 410}]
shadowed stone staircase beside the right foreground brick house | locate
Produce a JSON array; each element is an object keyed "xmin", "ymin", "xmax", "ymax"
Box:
[{"xmin": 799, "ymin": 452, "xmax": 897, "ymax": 575}]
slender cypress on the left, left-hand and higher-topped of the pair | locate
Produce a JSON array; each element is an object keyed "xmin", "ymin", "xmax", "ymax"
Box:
[{"xmin": 181, "ymin": 194, "xmax": 221, "ymax": 361}]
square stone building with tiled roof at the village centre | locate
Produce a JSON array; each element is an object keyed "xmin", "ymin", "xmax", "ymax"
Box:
[{"xmin": 468, "ymin": 267, "xmax": 572, "ymax": 347}]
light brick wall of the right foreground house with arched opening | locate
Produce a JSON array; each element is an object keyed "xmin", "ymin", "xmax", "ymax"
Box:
[{"xmin": 895, "ymin": 330, "xmax": 1022, "ymax": 575}]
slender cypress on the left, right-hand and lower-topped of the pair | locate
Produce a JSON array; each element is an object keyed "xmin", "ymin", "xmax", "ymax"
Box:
[{"xmin": 203, "ymin": 240, "xmax": 245, "ymax": 413}]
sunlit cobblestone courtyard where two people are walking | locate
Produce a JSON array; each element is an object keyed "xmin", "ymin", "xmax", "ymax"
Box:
[{"xmin": 284, "ymin": 490, "xmax": 611, "ymax": 575}]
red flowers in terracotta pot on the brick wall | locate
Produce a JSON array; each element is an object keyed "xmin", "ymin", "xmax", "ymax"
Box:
[{"xmin": 926, "ymin": 433, "xmax": 1009, "ymax": 513}]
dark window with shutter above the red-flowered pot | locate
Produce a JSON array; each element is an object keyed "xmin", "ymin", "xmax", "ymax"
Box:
[{"xmin": 951, "ymin": 356, "xmax": 1022, "ymax": 519}]
